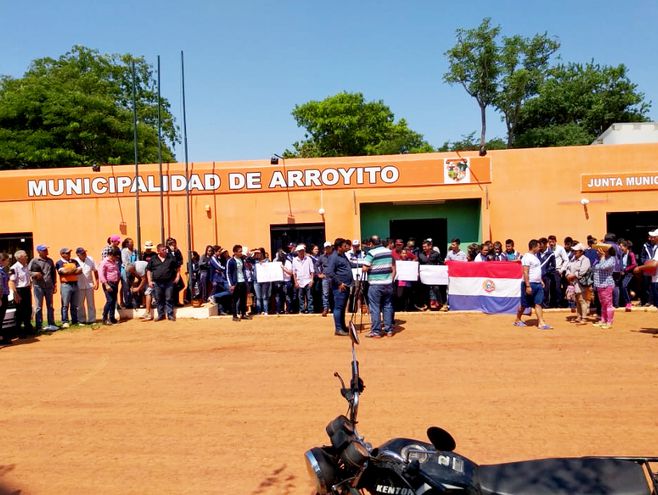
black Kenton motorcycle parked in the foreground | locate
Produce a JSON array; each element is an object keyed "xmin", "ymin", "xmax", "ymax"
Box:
[{"xmin": 305, "ymin": 321, "xmax": 658, "ymax": 495}]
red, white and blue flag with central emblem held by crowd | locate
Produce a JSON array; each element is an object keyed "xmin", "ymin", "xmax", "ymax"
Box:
[{"xmin": 447, "ymin": 261, "xmax": 523, "ymax": 313}]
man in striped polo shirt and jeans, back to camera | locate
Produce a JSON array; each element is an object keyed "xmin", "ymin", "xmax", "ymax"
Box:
[{"xmin": 363, "ymin": 235, "xmax": 395, "ymax": 339}]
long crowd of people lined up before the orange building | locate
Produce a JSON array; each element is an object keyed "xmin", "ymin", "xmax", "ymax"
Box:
[{"xmin": 0, "ymin": 230, "xmax": 658, "ymax": 344}]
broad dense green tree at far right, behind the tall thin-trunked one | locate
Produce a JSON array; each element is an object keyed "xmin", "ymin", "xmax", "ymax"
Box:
[{"xmin": 515, "ymin": 62, "xmax": 651, "ymax": 147}]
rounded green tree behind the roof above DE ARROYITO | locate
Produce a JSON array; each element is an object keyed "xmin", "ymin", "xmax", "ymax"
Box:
[{"xmin": 285, "ymin": 92, "xmax": 433, "ymax": 157}]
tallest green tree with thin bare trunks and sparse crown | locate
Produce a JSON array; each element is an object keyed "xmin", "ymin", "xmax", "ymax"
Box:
[{"xmin": 443, "ymin": 18, "xmax": 560, "ymax": 149}]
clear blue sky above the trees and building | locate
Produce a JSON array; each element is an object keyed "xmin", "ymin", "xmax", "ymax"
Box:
[{"xmin": 0, "ymin": 0, "xmax": 658, "ymax": 161}]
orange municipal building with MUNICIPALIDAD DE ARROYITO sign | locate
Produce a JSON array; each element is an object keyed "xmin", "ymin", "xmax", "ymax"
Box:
[{"xmin": 0, "ymin": 140, "xmax": 658, "ymax": 274}]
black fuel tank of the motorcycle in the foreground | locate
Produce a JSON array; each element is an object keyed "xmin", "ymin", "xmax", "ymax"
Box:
[{"xmin": 373, "ymin": 438, "xmax": 477, "ymax": 494}]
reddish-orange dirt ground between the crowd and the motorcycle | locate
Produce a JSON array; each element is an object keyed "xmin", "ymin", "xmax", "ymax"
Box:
[{"xmin": 0, "ymin": 312, "xmax": 658, "ymax": 495}]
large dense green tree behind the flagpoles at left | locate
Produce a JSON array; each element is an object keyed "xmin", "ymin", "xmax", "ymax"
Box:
[{"xmin": 0, "ymin": 46, "xmax": 178, "ymax": 168}]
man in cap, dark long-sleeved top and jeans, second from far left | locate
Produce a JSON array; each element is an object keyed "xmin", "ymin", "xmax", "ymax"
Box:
[{"xmin": 27, "ymin": 244, "xmax": 59, "ymax": 332}]
